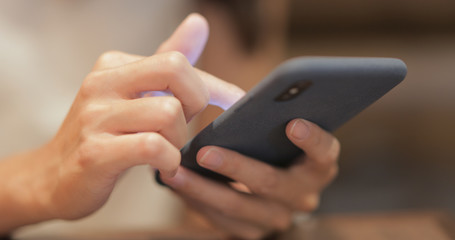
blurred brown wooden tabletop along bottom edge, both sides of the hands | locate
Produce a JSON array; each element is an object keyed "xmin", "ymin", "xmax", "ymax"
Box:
[{"xmin": 11, "ymin": 211, "xmax": 455, "ymax": 240}]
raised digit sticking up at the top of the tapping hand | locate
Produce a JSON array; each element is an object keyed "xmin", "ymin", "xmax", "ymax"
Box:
[{"xmin": 156, "ymin": 13, "xmax": 209, "ymax": 65}]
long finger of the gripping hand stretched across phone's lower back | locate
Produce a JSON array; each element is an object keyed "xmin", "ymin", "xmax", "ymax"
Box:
[{"xmin": 197, "ymin": 146, "xmax": 328, "ymax": 212}]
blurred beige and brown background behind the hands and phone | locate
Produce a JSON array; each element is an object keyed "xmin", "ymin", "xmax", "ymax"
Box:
[{"xmin": 0, "ymin": 0, "xmax": 455, "ymax": 236}]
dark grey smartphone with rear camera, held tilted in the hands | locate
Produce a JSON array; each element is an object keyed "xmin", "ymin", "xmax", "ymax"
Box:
[{"xmin": 157, "ymin": 57, "xmax": 407, "ymax": 181}]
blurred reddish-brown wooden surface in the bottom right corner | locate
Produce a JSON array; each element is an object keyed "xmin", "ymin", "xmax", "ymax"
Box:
[{"xmin": 278, "ymin": 212, "xmax": 455, "ymax": 240}]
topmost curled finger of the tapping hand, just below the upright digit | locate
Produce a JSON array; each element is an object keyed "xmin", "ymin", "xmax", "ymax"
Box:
[{"xmin": 89, "ymin": 52, "xmax": 209, "ymax": 121}]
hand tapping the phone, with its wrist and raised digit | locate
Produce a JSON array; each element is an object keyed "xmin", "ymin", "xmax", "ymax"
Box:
[{"xmin": 0, "ymin": 14, "xmax": 244, "ymax": 233}]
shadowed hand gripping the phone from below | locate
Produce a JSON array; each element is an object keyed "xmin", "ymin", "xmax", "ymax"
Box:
[{"xmin": 163, "ymin": 119, "xmax": 340, "ymax": 239}]
